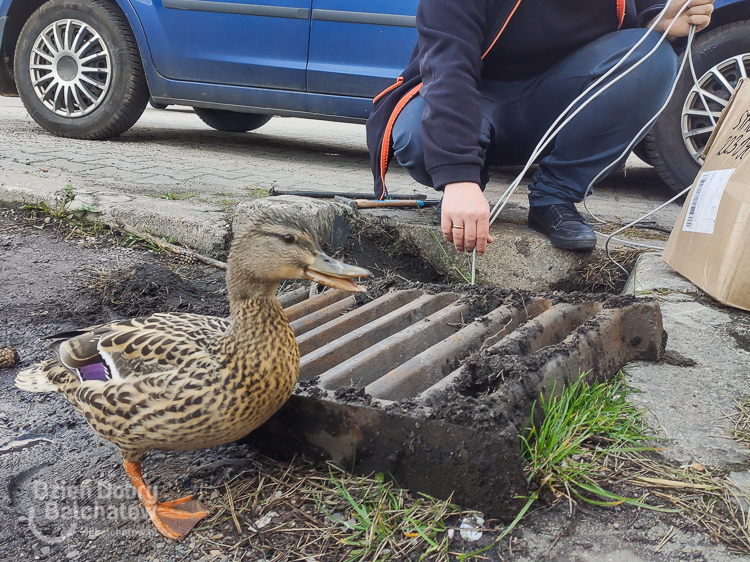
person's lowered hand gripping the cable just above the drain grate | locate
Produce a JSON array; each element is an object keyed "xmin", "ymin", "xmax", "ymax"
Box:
[{"xmin": 440, "ymin": 182, "xmax": 492, "ymax": 256}]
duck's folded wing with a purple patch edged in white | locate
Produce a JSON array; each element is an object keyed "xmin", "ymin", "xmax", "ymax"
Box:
[{"xmin": 50, "ymin": 313, "xmax": 229, "ymax": 382}]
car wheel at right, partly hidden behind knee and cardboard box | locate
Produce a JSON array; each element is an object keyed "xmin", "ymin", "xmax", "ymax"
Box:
[{"xmin": 643, "ymin": 21, "xmax": 750, "ymax": 192}]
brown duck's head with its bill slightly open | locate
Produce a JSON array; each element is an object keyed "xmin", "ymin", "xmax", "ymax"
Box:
[{"xmin": 227, "ymin": 208, "xmax": 372, "ymax": 301}]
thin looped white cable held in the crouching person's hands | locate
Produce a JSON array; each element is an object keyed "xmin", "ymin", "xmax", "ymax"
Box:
[{"xmin": 471, "ymin": 0, "xmax": 694, "ymax": 285}]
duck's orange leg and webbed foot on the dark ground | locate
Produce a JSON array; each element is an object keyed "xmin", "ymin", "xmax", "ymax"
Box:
[{"xmin": 123, "ymin": 461, "xmax": 209, "ymax": 540}]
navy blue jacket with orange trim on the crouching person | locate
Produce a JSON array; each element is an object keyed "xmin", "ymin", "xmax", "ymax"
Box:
[{"xmin": 367, "ymin": 0, "xmax": 664, "ymax": 198}]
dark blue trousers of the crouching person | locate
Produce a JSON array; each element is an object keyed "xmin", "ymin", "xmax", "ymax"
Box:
[{"xmin": 393, "ymin": 29, "xmax": 679, "ymax": 205}]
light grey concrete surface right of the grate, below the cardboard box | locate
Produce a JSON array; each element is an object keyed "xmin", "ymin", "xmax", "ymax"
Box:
[{"xmin": 623, "ymin": 253, "xmax": 750, "ymax": 467}]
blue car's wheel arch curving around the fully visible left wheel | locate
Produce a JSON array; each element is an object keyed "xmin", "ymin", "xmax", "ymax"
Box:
[{"xmin": 0, "ymin": 0, "xmax": 155, "ymax": 96}]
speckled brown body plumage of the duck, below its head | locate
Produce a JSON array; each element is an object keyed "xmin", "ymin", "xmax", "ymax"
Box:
[{"xmin": 21, "ymin": 299, "xmax": 299, "ymax": 461}]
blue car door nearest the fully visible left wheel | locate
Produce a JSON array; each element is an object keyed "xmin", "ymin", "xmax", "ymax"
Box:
[{"xmin": 134, "ymin": 0, "xmax": 312, "ymax": 91}]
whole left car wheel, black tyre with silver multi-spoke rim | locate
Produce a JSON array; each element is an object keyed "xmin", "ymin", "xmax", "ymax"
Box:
[{"xmin": 15, "ymin": 0, "xmax": 149, "ymax": 139}]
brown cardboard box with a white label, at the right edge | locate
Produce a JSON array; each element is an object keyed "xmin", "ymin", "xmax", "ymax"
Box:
[{"xmin": 664, "ymin": 80, "xmax": 750, "ymax": 310}]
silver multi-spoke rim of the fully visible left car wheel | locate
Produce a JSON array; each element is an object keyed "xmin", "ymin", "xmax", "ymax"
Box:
[{"xmin": 30, "ymin": 19, "xmax": 112, "ymax": 117}]
